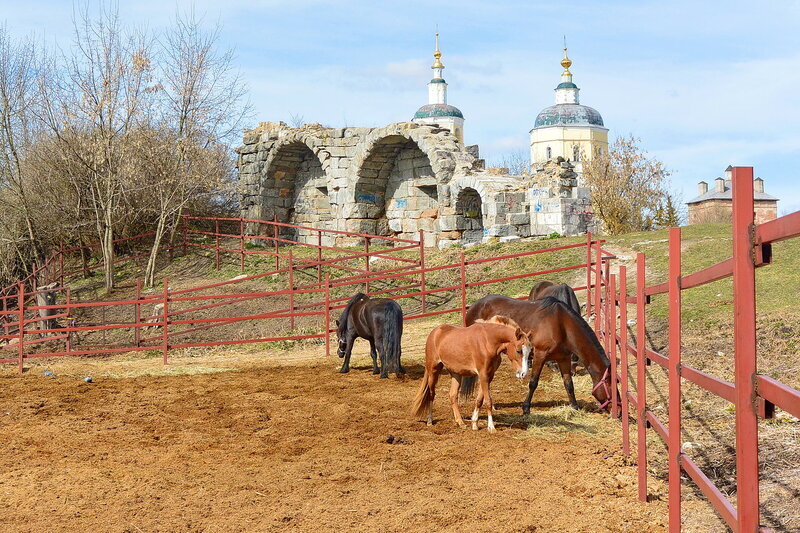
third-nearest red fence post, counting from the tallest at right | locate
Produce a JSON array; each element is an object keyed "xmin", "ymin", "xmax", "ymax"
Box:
[{"xmin": 636, "ymin": 252, "xmax": 647, "ymax": 502}]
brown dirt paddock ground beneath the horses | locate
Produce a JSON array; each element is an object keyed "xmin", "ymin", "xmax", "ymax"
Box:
[{"xmin": 0, "ymin": 332, "xmax": 666, "ymax": 533}]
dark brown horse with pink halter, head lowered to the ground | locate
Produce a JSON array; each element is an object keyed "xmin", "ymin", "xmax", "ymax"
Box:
[{"xmin": 467, "ymin": 294, "xmax": 619, "ymax": 414}]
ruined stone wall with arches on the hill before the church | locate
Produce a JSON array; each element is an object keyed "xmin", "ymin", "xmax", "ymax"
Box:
[{"xmin": 237, "ymin": 122, "xmax": 591, "ymax": 248}]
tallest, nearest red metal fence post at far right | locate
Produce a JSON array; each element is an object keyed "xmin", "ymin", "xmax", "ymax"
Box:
[{"xmin": 733, "ymin": 167, "xmax": 759, "ymax": 533}]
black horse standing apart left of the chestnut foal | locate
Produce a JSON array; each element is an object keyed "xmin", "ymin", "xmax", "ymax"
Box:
[{"xmin": 336, "ymin": 292, "xmax": 405, "ymax": 378}]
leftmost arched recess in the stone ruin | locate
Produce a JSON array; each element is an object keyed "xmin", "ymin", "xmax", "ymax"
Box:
[{"xmin": 261, "ymin": 136, "xmax": 335, "ymax": 242}]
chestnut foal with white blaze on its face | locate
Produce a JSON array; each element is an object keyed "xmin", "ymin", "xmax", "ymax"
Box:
[{"xmin": 412, "ymin": 316, "xmax": 531, "ymax": 433}]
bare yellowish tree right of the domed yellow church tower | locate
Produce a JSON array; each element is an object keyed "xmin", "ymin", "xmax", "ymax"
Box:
[{"xmin": 583, "ymin": 136, "xmax": 669, "ymax": 235}]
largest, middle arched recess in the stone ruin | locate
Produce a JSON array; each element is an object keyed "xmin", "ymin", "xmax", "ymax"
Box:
[{"xmin": 345, "ymin": 128, "xmax": 440, "ymax": 244}]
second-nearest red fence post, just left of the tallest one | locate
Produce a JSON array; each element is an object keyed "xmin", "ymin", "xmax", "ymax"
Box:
[{"xmin": 667, "ymin": 228, "xmax": 683, "ymax": 533}]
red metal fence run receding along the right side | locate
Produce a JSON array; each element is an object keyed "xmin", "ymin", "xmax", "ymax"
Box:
[{"xmin": 595, "ymin": 167, "xmax": 800, "ymax": 533}]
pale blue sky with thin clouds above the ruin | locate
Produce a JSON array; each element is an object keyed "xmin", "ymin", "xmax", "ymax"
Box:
[{"xmin": 6, "ymin": 0, "xmax": 800, "ymax": 213}]
